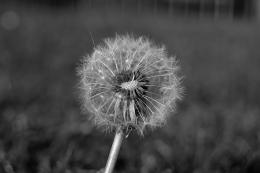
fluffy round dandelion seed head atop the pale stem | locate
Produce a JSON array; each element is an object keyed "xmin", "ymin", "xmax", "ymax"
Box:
[{"xmin": 78, "ymin": 35, "xmax": 181, "ymax": 133}]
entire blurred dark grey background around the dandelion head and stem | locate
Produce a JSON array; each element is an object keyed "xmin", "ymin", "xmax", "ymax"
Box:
[{"xmin": 0, "ymin": 0, "xmax": 260, "ymax": 173}]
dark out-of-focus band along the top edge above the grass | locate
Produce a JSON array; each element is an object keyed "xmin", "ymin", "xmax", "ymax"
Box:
[{"xmin": 0, "ymin": 0, "xmax": 258, "ymax": 17}]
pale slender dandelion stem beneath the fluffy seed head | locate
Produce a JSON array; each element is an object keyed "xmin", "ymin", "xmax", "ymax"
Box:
[{"xmin": 104, "ymin": 128, "xmax": 124, "ymax": 173}]
